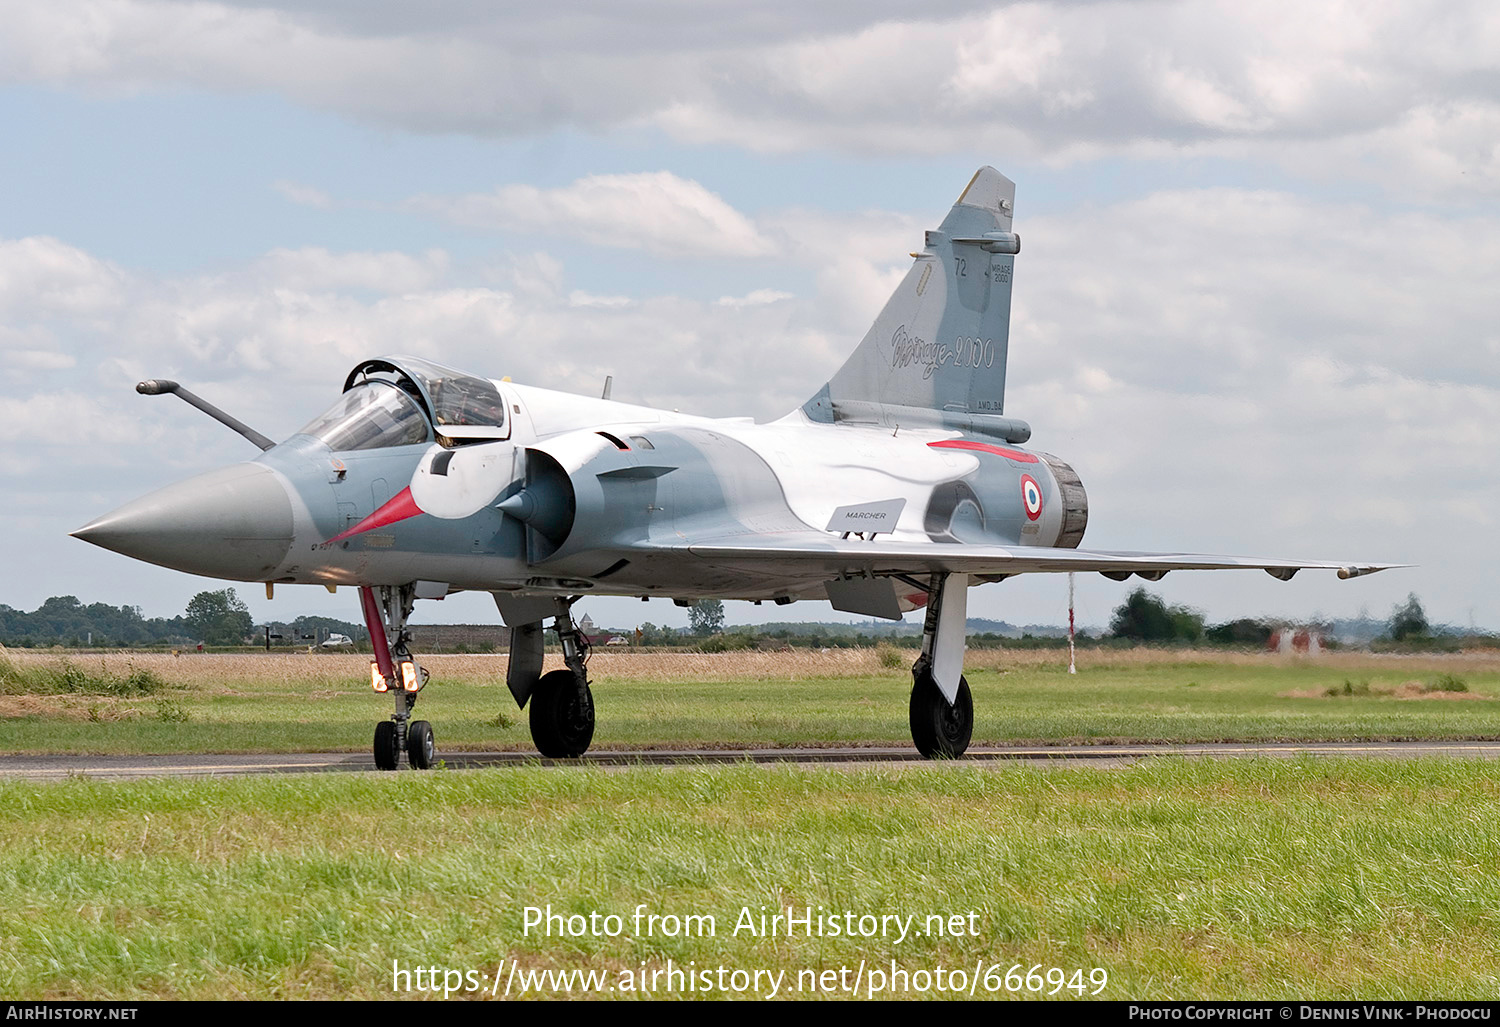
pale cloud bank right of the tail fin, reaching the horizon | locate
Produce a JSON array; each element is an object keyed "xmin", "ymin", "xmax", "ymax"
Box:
[{"xmin": 1007, "ymin": 189, "xmax": 1500, "ymax": 624}]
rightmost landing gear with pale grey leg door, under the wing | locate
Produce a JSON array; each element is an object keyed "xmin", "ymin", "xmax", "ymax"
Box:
[{"xmin": 909, "ymin": 574, "xmax": 974, "ymax": 760}]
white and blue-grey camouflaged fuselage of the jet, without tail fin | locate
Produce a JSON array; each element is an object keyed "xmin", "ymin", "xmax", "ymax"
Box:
[{"xmin": 113, "ymin": 381, "xmax": 1082, "ymax": 601}]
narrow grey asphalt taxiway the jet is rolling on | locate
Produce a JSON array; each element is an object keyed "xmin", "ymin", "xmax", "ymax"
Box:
[{"xmin": 0, "ymin": 741, "xmax": 1500, "ymax": 781}]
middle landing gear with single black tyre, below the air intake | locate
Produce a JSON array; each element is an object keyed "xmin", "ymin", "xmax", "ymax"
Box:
[{"xmin": 501, "ymin": 598, "xmax": 594, "ymax": 759}]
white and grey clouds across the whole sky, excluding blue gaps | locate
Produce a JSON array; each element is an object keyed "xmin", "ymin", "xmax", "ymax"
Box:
[{"xmin": 0, "ymin": 0, "xmax": 1500, "ymax": 624}]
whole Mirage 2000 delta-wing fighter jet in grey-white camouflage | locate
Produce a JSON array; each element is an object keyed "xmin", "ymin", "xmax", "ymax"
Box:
[{"xmin": 74, "ymin": 168, "xmax": 1382, "ymax": 769}]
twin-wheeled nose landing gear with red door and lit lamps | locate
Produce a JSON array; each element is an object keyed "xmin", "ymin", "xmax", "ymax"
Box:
[{"xmin": 360, "ymin": 585, "xmax": 437, "ymax": 771}]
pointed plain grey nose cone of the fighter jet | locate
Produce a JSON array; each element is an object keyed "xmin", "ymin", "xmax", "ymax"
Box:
[{"xmin": 72, "ymin": 463, "xmax": 293, "ymax": 582}]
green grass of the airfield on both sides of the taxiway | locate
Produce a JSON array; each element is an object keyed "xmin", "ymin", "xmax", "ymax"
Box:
[{"xmin": 0, "ymin": 651, "xmax": 1500, "ymax": 999}]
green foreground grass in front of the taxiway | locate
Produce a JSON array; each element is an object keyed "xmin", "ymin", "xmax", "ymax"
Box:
[{"xmin": 0, "ymin": 760, "xmax": 1500, "ymax": 999}]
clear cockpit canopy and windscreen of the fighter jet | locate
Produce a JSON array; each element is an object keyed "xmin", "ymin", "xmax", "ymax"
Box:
[{"xmin": 300, "ymin": 357, "xmax": 510, "ymax": 451}]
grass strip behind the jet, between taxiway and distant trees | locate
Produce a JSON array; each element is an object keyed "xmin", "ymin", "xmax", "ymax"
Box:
[{"xmin": 0, "ymin": 649, "xmax": 1500, "ymax": 753}]
